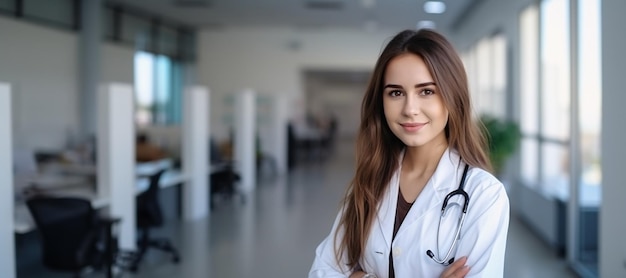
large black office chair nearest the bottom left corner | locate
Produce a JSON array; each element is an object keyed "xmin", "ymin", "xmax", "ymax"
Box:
[{"xmin": 26, "ymin": 196, "xmax": 120, "ymax": 277}]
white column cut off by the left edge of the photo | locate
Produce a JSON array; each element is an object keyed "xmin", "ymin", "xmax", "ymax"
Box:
[{"xmin": 0, "ymin": 83, "xmax": 15, "ymax": 278}]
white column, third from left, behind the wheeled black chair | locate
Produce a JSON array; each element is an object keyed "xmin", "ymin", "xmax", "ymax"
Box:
[{"xmin": 182, "ymin": 86, "xmax": 210, "ymax": 220}]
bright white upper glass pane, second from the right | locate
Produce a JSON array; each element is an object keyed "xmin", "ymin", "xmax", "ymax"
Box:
[{"xmin": 541, "ymin": 0, "xmax": 570, "ymax": 140}]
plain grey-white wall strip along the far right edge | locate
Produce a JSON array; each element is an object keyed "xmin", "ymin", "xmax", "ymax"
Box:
[{"xmin": 599, "ymin": 0, "xmax": 626, "ymax": 277}]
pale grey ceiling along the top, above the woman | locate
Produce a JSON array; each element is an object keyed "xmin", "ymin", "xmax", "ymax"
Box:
[{"xmin": 109, "ymin": 0, "xmax": 479, "ymax": 30}]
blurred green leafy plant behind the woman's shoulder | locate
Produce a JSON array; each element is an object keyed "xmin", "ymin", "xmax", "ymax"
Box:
[{"xmin": 480, "ymin": 115, "xmax": 521, "ymax": 175}]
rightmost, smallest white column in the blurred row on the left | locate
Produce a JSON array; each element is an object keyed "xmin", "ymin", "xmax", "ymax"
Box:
[{"xmin": 272, "ymin": 96, "xmax": 289, "ymax": 175}]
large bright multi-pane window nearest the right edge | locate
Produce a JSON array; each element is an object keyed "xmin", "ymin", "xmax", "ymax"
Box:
[{"xmin": 519, "ymin": 0, "xmax": 602, "ymax": 277}]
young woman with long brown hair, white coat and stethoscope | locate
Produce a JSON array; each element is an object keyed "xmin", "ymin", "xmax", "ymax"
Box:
[{"xmin": 309, "ymin": 30, "xmax": 509, "ymax": 278}]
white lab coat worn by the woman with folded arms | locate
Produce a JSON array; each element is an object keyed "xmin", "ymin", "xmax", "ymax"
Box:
[{"xmin": 309, "ymin": 149, "xmax": 509, "ymax": 278}]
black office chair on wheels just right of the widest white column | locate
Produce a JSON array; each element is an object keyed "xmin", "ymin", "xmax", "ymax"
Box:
[{"xmin": 129, "ymin": 170, "xmax": 180, "ymax": 271}]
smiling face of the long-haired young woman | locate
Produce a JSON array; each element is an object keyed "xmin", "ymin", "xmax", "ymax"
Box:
[{"xmin": 383, "ymin": 54, "xmax": 448, "ymax": 147}]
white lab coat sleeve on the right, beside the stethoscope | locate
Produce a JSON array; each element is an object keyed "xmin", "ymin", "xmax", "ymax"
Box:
[{"xmin": 456, "ymin": 175, "xmax": 509, "ymax": 278}]
